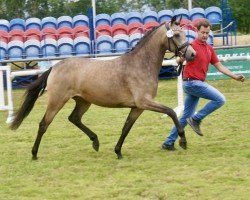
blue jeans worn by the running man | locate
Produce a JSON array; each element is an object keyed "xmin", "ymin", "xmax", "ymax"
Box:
[{"xmin": 164, "ymin": 80, "xmax": 226, "ymax": 145}]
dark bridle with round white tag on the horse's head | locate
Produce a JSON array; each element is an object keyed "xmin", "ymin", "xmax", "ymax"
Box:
[{"xmin": 166, "ymin": 23, "xmax": 190, "ymax": 57}]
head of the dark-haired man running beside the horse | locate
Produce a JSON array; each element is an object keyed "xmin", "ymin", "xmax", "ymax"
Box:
[{"xmin": 196, "ymin": 19, "xmax": 212, "ymax": 42}]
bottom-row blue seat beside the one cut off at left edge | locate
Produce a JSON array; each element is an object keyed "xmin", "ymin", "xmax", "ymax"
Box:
[{"xmin": 8, "ymin": 40, "xmax": 24, "ymax": 60}]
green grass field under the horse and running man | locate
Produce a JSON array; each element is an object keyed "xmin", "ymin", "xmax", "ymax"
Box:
[{"xmin": 0, "ymin": 80, "xmax": 250, "ymax": 200}]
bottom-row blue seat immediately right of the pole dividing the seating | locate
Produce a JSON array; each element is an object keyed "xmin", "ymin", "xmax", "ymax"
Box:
[{"xmin": 96, "ymin": 35, "xmax": 113, "ymax": 54}]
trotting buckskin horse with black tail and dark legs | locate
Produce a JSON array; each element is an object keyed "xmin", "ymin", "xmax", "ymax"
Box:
[{"xmin": 10, "ymin": 17, "xmax": 196, "ymax": 160}]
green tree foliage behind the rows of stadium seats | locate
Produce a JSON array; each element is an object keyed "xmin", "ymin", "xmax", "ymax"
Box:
[{"xmin": 0, "ymin": 0, "xmax": 247, "ymax": 33}]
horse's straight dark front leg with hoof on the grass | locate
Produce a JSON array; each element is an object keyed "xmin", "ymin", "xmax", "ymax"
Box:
[{"xmin": 115, "ymin": 108, "xmax": 143, "ymax": 159}]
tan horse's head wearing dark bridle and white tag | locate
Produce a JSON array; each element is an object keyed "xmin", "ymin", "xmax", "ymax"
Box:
[{"xmin": 165, "ymin": 16, "xmax": 196, "ymax": 61}]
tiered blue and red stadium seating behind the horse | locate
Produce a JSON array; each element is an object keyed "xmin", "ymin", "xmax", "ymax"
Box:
[{"xmin": 0, "ymin": 7, "xmax": 222, "ymax": 60}]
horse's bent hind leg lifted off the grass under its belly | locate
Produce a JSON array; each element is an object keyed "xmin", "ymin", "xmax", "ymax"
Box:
[{"xmin": 69, "ymin": 97, "xmax": 99, "ymax": 151}]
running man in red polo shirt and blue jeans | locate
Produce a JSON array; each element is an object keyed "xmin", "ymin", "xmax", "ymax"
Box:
[{"xmin": 162, "ymin": 19, "xmax": 245, "ymax": 151}]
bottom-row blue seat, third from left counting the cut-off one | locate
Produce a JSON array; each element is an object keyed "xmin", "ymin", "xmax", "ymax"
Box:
[{"xmin": 24, "ymin": 39, "xmax": 41, "ymax": 58}]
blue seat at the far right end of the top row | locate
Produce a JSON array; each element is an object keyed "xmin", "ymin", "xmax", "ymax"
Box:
[{"xmin": 205, "ymin": 6, "xmax": 222, "ymax": 24}]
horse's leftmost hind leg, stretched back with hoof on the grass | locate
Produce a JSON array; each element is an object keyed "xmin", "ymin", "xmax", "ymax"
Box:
[{"xmin": 32, "ymin": 100, "xmax": 66, "ymax": 160}]
